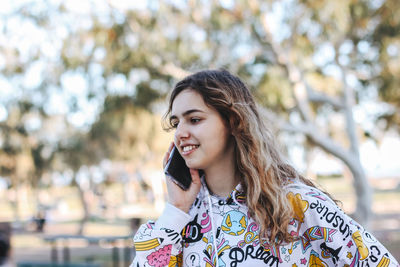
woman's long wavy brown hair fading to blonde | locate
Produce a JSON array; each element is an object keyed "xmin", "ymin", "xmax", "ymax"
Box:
[{"xmin": 164, "ymin": 70, "xmax": 322, "ymax": 245}]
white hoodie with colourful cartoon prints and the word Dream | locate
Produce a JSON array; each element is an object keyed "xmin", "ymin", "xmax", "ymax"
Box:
[{"xmin": 132, "ymin": 183, "xmax": 400, "ymax": 267}]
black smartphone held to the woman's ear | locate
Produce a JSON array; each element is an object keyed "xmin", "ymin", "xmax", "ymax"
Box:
[{"xmin": 164, "ymin": 146, "xmax": 192, "ymax": 190}]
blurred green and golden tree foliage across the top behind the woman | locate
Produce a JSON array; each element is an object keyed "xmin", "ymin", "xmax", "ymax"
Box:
[{"xmin": 0, "ymin": 0, "xmax": 400, "ymax": 193}]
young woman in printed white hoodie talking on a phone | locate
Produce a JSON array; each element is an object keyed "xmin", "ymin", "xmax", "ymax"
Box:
[{"xmin": 132, "ymin": 70, "xmax": 399, "ymax": 267}]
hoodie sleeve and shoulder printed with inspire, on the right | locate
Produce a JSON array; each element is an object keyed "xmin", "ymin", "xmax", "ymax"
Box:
[{"xmin": 285, "ymin": 181, "xmax": 398, "ymax": 266}]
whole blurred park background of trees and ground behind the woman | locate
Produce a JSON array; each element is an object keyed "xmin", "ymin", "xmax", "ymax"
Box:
[{"xmin": 0, "ymin": 0, "xmax": 400, "ymax": 266}]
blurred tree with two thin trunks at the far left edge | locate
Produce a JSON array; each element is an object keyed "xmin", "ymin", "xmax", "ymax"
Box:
[{"xmin": 0, "ymin": 99, "xmax": 63, "ymax": 221}]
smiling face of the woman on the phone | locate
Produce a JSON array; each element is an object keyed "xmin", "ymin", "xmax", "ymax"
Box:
[{"xmin": 170, "ymin": 89, "xmax": 233, "ymax": 171}]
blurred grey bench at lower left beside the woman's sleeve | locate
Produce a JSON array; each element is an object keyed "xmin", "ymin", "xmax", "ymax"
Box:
[{"xmin": 43, "ymin": 235, "xmax": 134, "ymax": 267}]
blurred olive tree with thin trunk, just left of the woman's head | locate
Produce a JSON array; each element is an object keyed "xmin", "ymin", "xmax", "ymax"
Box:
[{"xmin": 54, "ymin": 96, "xmax": 168, "ymax": 234}]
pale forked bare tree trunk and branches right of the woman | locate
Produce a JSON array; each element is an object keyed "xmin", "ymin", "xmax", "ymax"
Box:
[{"xmin": 252, "ymin": 9, "xmax": 372, "ymax": 226}]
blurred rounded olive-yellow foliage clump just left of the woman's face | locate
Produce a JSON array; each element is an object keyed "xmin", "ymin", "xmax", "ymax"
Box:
[{"xmin": 88, "ymin": 96, "xmax": 164, "ymax": 161}]
